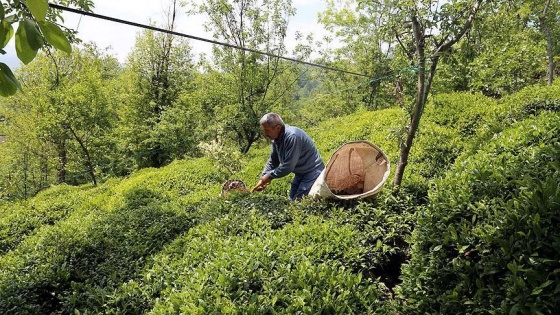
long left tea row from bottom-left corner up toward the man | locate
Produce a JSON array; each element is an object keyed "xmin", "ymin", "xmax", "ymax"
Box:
[{"xmin": 0, "ymin": 160, "xmax": 223, "ymax": 313}]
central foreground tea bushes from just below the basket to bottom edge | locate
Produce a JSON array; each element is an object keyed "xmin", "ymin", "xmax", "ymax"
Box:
[{"xmin": 100, "ymin": 194, "xmax": 412, "ymax": 314}]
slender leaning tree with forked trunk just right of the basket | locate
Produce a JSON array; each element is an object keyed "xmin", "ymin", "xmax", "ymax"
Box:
[{"xmin": 322, "ymin": 0, "xmax": 483, "ymax": 189}]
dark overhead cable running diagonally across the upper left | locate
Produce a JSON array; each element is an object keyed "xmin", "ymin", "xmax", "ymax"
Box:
[{"xmin": 49, "ymin": 3, "xmax": 370, "ymax": 78}]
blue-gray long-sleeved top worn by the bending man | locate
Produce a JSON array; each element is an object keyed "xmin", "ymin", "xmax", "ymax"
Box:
[{"xmin": 261, "ymin": 125, "xmax": 324, "ymax": 179}]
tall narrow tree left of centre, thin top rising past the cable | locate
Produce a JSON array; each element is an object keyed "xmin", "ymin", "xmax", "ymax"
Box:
[{"xmin": 117, "ymin": 1, "xmax": 194, "ymax": 171}]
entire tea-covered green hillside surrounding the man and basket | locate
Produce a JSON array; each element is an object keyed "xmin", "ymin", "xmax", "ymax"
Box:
[{"xmin": 0, "ymin": 80, "xmax": 560, "ymax": 314}]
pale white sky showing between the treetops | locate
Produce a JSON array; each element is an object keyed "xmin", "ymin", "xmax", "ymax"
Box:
[{"xmin": 0, "ymin": 0, "xmax": 332, "ymax": 69}]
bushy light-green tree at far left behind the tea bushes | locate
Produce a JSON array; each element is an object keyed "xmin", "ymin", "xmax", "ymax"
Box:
[{"xmin": 2, "ymin": 45, "xmax": 120, "ymax": 198}]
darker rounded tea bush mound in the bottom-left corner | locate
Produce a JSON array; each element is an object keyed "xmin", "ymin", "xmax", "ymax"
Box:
[{"xmin": 0, "ymin": 189, "xmax": 190, "ymax": 313}]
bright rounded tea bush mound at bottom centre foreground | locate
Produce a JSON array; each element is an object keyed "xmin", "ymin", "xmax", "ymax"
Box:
[{"xmin": 106, "ymin": 209, "xmax": 390, "ymax": 314}]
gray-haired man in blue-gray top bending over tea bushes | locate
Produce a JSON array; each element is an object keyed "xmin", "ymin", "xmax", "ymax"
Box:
[{"xmin": 253, "ymin": 113, "xmax": 325, "ymax": 200}]
